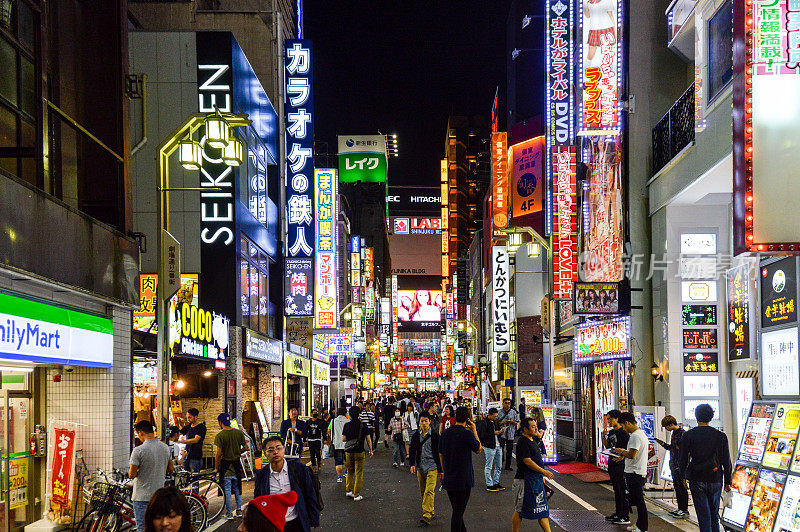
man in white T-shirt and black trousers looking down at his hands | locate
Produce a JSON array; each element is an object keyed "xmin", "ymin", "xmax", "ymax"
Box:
[{"xmin": 614, "ymin": 412, "xmax": 650, "ymax": 532}]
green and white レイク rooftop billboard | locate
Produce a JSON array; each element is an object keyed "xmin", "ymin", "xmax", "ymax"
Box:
[{"xmin": 339, "ymin": 135, "xmax": 386, "ymax": 183}]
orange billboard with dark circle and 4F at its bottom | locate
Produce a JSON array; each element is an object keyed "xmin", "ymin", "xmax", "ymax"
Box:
[{"xmin": 509, "ymin": 136, "xmax": 545, "ymax": 222}]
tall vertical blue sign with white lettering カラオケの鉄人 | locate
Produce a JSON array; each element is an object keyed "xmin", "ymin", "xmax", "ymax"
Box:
[{"xmin": 284, "ymin": 39, "xmax": 314, "ymax": 259}]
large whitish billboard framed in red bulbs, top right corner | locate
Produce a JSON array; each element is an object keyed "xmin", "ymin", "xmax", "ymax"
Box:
[{"xmin": 733, "ymin": 0, "xmax": 800, "ymax": 254}]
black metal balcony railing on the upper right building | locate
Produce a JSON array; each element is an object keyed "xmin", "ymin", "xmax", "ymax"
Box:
[{"xmin": 653, "ymin": 85, "xmax": 694, "ymax": 175}]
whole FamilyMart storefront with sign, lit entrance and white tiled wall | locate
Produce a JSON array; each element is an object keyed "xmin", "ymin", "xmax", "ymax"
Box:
[{"xmin": 0, "ymin": 284, "xmax": 131, "ymax": 532}]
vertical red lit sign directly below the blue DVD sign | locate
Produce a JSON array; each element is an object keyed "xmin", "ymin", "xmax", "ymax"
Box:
[{"xmin": 553, "ymin": 146, "xmax": 578, "ymax": 299}]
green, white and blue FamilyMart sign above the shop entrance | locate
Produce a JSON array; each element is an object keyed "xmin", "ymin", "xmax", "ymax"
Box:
[{"xmin": 0, "ymin": 293, "xmax": 114, "ymax": 368}]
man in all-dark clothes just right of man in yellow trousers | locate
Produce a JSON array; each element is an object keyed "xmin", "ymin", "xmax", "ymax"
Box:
[{"xmin": 439, "ymin": 406, "xmax": 481, "ymax": 532}]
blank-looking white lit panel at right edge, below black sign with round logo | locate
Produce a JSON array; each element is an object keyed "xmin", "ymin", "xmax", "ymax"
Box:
[{"xmin": 761, "ymin": 327, "xmax": 800, "ymax": 397}]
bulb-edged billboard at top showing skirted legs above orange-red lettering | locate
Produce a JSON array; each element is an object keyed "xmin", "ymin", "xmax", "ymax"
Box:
[{"xmin": 579, "ymin": 0, "xmax": 622, "ymax": 134}]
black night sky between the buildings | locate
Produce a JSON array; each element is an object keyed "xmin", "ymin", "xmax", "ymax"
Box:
[{"xmin": 303, "ymin": 0, "xmax": 511, "ymax": 186}]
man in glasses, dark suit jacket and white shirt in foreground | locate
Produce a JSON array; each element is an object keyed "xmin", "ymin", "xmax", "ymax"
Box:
[{"xmin": 253, "ymin": 436, "xmax": 321, "ymax": 532}]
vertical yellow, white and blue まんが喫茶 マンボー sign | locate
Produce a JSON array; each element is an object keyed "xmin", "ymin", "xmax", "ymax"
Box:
[{"xmin": 314, "ymin": 169, "xmax": 339, "ymax": 329}]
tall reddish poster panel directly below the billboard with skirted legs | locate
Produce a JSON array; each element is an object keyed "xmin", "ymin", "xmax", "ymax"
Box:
[{"xmin": 581, "ymin": 136, "xmax": 623, "ymax": 281}]
